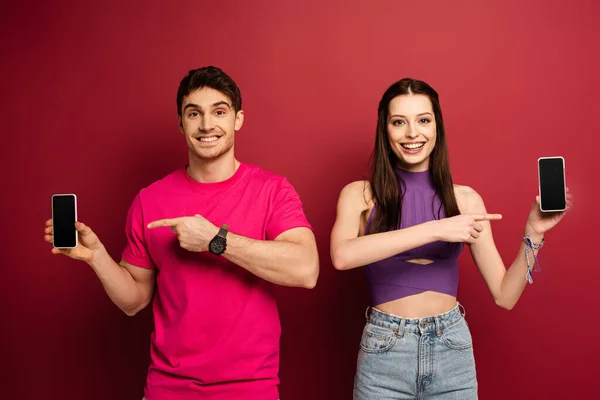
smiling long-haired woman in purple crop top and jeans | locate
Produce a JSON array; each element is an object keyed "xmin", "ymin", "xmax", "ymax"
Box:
[{"xmin": 331, "ymin": 79, "xmax": 571, "ymax": 400}]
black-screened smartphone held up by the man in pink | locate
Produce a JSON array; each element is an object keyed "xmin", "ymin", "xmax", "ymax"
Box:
[{"xmin": 52, "ymin": 194, "xmax": 78, "ymax": 249}]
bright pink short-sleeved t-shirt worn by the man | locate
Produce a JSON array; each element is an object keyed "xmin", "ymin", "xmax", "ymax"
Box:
[{"xmin": 123, "ymin": 163, "xmax": 312, "ymax": 400}]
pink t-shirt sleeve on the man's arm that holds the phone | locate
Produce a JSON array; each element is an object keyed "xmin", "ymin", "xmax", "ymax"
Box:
[{"xmin": 122, "ymin": 194, "xmax": 154, "ymax": 269}]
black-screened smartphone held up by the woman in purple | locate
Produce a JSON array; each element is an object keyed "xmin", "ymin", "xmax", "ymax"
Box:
[{"xmin": 538, "ymin": 157, "xmax": 567, "ymax": 212}]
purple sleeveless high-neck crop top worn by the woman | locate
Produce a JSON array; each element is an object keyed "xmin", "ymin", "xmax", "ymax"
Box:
[{"xmin": 364, "ymin": 168, "xmax": 464, "ymax": 306}]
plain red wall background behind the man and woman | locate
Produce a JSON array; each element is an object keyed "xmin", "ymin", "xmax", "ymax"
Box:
[{"xmin": 0, "ymin": 0, "xmax": 600, "ymax": 400}]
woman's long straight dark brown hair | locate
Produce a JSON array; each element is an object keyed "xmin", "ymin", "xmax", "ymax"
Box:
[{"xmin": 369, "ymin": 78, "xmax": 460, "ymax": 233}]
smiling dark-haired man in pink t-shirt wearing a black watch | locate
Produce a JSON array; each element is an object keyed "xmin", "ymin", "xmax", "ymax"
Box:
[{"xmin": 45, "ymin": 67, "xmax": 319, "ymax": 400}]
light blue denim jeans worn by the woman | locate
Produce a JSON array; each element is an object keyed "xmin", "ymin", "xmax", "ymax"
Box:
[{"xmin": 354, "ymin": 303, "xmax": 477, "ymax": 400}]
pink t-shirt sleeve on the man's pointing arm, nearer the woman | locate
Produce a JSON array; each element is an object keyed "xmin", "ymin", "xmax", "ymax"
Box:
[{"xmin": 266, "ymin": 178, "xmax": 312, "ymax": 240}]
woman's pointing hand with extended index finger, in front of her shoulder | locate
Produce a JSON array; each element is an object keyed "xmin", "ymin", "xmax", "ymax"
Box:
[{"xmin": 436, "ymin": 214, "xmax": 502, "ymax": 244}]
